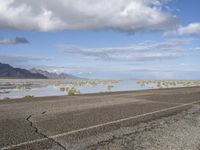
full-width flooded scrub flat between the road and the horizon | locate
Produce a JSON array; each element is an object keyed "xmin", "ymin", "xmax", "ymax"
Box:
[{"xmin": 0, "ymin": 80, "xmax": 200, "ymax": 99}]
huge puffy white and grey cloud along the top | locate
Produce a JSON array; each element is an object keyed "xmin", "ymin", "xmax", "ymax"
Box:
[{"xmin": 0, "ymin": 0, "xmax": 178, "ymax": 32}]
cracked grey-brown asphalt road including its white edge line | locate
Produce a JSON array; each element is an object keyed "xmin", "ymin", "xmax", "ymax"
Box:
[{"xmin": 0, "ymin": 87, "xmax": 200, "ymax": 150}]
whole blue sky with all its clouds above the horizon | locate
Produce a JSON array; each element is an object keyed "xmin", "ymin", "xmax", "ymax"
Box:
[{"xmin": 0, "ymin": 0, "xmax": 200, "ymax": 80}]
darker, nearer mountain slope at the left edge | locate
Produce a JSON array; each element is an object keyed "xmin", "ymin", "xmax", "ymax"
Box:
[{"xmin": 0, "ymin": 63, "xmax": 47, "ymax": 79}]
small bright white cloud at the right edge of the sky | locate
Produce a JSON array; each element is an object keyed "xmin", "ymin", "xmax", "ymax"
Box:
[{"xmin": 165, "ymin": 23, "xmax": 200, "ymax": 36}]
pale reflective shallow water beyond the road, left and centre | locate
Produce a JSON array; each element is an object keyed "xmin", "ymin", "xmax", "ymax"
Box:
[{"xmin": 0, "ymin": 80, "xmax": 147, "ymax": 99}]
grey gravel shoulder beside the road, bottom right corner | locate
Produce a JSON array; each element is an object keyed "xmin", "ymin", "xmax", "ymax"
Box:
[{"xmin": 85, "ymin": 105, "xmax": 200, "ymax": 150}]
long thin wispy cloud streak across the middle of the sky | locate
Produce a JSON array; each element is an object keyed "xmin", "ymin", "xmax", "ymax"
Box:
[{"xmin": 59, "ymin": 39, "xmax": 189, "ymax": 61}]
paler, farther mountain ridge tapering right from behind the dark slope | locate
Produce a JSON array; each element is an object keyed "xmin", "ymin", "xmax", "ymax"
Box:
[{"xmin": 30, "ymin": 68, "xmax": 79, "ymax": 79}]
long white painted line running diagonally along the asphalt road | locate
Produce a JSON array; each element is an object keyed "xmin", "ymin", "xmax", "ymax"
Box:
[{"xmin": 1, "ymin": 101, "xmax": 200, "ymax": 150}]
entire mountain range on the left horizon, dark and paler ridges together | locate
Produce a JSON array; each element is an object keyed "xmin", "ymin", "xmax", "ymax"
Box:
[{"xmin": 0, "ymin": 63, "xmax": 78, "ymax": 79}]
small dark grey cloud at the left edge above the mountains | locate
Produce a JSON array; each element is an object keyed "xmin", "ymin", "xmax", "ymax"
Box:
[{"xmin": 0, "ymin": 37, "xmax": 29, "ymax": 45}]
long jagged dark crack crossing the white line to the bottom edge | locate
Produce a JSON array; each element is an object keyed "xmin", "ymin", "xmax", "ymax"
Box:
[{"xmin": 26, "ymin": 115, "xmax": 67, "ymax": 150}]
